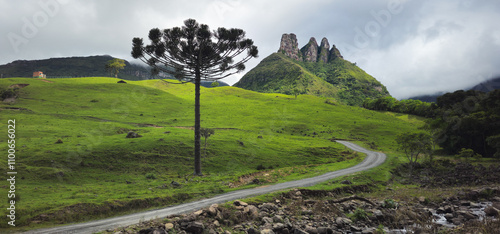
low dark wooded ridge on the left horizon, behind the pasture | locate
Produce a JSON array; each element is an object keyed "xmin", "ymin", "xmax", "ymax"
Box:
[{"xmin": 0, "ymin": 55, "xmax": 229, "ymax": 87}]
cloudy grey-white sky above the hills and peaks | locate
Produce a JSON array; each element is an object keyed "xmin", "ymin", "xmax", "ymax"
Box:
[{"xmin": 0, "ymin": 0, "xmax": 500, "ymax": 98}]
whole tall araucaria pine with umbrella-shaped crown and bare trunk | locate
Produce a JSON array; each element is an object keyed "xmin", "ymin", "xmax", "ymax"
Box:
[{"xmin": 132, "ymin": 19, "xmax": 258, "ymax": 176}]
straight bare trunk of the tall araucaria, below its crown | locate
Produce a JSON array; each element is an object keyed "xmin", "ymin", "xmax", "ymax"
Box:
[{"xmin": 194, "ymin": 68, "xmax": 203, "ymax": 176}]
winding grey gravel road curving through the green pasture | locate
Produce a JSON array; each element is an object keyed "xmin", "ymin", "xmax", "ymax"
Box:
[{"xmin": 26, "ymin": 141, "xmax": 386, "ymax": 234}]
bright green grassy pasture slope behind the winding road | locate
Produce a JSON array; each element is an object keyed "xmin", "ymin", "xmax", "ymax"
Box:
[{"xmin": 0, "ymin": 77, "xmax": 422, "ymax": 228}]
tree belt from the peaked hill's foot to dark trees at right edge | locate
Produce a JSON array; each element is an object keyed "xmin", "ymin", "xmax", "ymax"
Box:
[{"xmin": 363, "ymin": 90, "xmax": 500, "ymax": 158}]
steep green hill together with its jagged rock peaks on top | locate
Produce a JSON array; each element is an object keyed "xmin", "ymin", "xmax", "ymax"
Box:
[{"xmin": 234, "ymin": 34, "xmax": 389, "ymax": 105}]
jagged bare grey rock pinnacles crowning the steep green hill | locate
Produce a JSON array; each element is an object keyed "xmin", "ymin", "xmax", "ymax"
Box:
[{"xmin": 278, "ymin": 33, "xmax": 343, "ymax": 63}]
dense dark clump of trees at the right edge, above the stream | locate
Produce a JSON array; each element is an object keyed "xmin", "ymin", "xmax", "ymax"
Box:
[{"xmin": 428, "ymin": 89, "xmax": 500, "ymax": 158}]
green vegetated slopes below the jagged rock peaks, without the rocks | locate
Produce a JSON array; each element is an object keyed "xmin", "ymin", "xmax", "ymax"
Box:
[{"xmin": 234, "ymin": 52, "xmax": 389, "ymax": 106}]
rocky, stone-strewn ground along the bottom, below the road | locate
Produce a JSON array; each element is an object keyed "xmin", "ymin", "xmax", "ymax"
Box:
[{"xmin": 107, "ymin": 186, "xmax": 500, "ymax": 234}]
